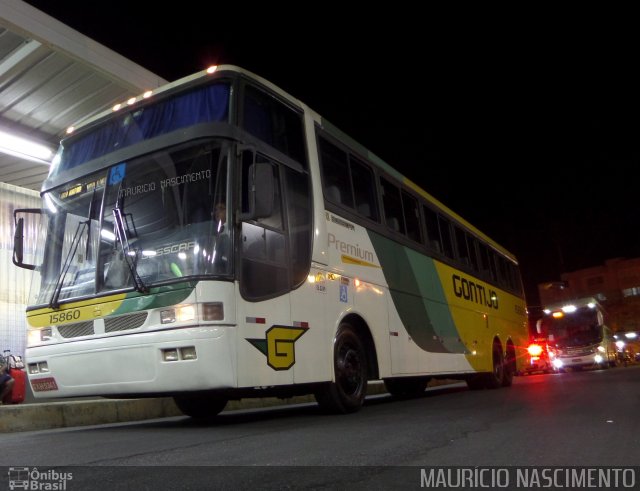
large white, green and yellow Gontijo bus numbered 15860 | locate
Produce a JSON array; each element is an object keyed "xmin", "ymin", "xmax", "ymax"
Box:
[{"xmin": 14, "ymin": 65, "xmax": 527, "ymax": 417}]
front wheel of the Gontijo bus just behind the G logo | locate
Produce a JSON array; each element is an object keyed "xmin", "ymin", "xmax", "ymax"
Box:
[{"xmin": 315, "ymin": 324, "xmax": 367, "ymax": 414}]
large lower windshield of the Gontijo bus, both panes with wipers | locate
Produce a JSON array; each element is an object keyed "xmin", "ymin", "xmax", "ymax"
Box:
[{"xmin": 32, "ymin": 139, "xmax": 232, "ymax": 306}]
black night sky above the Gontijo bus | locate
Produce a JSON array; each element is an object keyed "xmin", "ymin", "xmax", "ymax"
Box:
[{"xmin": 22, "ymin": 0, "xmax": 640, "ymax": 306}]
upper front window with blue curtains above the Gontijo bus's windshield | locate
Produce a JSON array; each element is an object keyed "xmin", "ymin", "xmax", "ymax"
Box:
[{"xmin": 51, "ymin": 83, "xmax": 229, "ymax": 175}]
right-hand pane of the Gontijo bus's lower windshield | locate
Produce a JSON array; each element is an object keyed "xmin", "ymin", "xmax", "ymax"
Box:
[{"xmin": 101, "ymin": 143, "xmax": 232, "ymax": 291}]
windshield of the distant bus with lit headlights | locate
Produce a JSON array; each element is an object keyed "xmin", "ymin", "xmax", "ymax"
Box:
[{"xmin": 542, "ymin": 308, "xmax": 603, "ymax": 348}]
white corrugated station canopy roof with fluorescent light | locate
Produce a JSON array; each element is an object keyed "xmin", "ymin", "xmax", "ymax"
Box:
[{"xmin": 0, "ymin": 0, "xmax": 167, "ymax": 191}]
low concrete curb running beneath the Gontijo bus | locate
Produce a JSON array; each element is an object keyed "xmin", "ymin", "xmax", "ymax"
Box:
[{"xmin": 0, "ymin": 382, "xmax": 386, "ymax": 433}]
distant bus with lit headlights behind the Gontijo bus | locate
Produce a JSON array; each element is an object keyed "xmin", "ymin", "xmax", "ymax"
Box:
[{"xmin": 538, "ymin": 298, "xmax": 617, "ymax": 370}]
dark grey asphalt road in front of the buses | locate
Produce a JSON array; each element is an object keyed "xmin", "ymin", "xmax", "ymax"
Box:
[{"xmin": 0, "ymin": 366, "xmax": 640, "ymax": 490}]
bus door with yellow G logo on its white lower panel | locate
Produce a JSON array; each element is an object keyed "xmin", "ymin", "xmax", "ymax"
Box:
[{"xmin": 238, "ymin": 150, "xmax": 321, "ymax": 387}]
